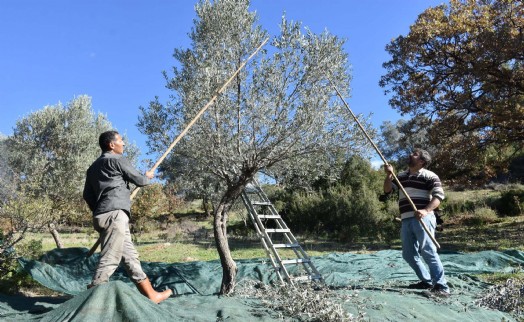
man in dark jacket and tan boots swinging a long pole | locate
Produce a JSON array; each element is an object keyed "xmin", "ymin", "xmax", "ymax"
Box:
[{"xmin": 83, "ymin": 131, "xmax": 173, "ymax": 303}]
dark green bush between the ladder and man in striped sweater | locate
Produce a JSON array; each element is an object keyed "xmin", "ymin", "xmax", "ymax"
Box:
[{"xmin": 264, "ymin": 156, "xmax": 392, "ymax": 242}]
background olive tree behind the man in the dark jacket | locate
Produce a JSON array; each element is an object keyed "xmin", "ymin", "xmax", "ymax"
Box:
[{"xmin": 4, "ymin": 96, "xmax": 111, "ymax": 248}]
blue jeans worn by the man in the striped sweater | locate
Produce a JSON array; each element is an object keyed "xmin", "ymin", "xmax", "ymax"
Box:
[{"xmin": 400, "ymin": 213, "xmax": 449, "ymax": 290}]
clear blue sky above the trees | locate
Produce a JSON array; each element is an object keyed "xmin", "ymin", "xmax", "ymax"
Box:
[{"xmin": 0, "ymin": 0, "xmax": 446, "ymax": 161}]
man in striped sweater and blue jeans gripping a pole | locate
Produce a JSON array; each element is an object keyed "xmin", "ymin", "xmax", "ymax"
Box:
[{"xmin": 384, "ymin": 149, "xmax": 449, "ymax": 297}]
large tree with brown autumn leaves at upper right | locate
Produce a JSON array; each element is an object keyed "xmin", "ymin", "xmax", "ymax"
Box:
[{"xmin": 380, "ymin": 0, "xmax": 524, "ymax": 179}]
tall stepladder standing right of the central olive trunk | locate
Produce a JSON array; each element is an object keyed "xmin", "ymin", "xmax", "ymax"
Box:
[{"xmin": 241, "ymin": 179, "xmax": 322, "ymax": 284}]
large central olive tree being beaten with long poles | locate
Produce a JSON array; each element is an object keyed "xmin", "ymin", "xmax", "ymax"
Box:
[{"xmin": 139, "ymin": 0, "xmax": 365, "ymax": 294}]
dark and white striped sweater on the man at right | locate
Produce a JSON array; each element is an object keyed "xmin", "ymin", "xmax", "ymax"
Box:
[{"xmin": 393, "ymin": 168, "xmax": 444, "ymax": 219}]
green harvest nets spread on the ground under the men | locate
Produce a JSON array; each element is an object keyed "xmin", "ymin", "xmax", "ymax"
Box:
[{"xmin": 0, "ymin": 248, "xmax": 524, "ymax": 322}]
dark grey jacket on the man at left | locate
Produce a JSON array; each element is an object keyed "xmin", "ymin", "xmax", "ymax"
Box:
[{"xmin": 83, "ymin": 152, "xmax": 149, "ymax": 216}]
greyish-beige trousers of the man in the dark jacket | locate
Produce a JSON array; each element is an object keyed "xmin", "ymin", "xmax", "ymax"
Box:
[{"xmin": 91, "ymin": 210, "xmax": 147, "ymax": 285}]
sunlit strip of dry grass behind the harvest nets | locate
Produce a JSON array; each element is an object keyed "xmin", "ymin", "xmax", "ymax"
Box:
[{"xmin": 24, "ymin": 216, "xmax": 524, "ymax": 263}]
